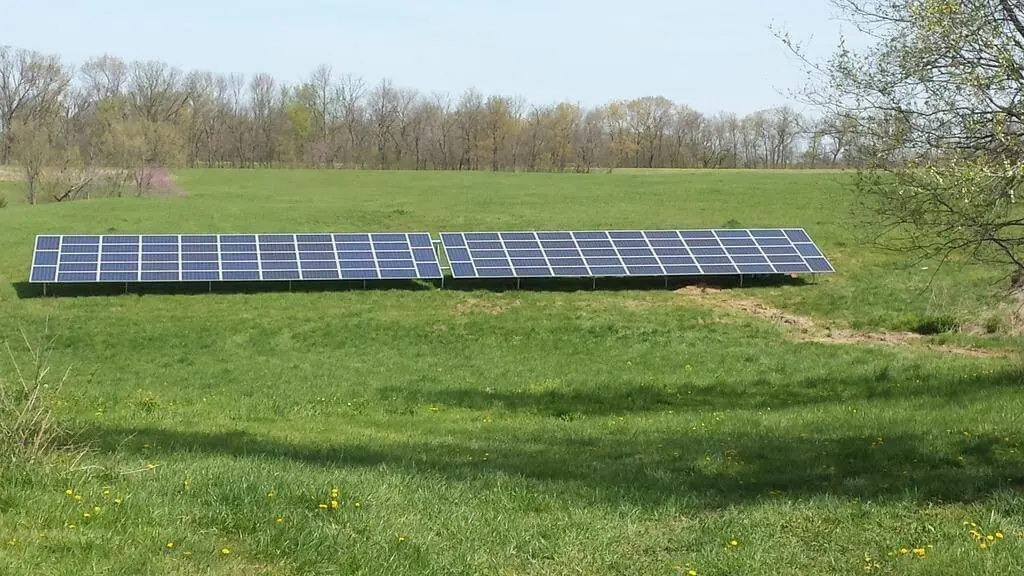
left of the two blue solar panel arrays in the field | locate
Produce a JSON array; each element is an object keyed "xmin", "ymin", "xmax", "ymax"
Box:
[{"xmin": 30, "ymin": 233, "xmax": 441, "ymax": 283}]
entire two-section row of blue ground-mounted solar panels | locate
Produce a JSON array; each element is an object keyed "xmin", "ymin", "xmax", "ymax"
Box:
[{"xmin": 30, "ymin": 228, "xmax": 835, "ymax": 293}]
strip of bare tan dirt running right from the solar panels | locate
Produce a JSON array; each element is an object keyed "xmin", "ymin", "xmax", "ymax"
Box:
[{"xmin": 676, "ymin": 285, "xmax": 1000, "ymax": 357}]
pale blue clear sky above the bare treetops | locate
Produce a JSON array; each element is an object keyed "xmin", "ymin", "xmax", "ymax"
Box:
[{"xmin": 0, "ymin": 0, "xmax": 841, "ymax": 114}]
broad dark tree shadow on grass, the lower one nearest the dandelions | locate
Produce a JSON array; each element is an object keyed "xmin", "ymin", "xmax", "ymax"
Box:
[{"xmin": 90, "ymin": 427, "xmax": 1024, "ymax": 507}]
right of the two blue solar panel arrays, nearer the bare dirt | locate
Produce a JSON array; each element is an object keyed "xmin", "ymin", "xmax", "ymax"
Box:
[{"xmin": 440, "ymin": 229, "xmax": 834, "ymax": 278}]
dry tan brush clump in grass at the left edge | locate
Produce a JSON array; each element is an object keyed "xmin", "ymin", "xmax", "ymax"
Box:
[{"xmin": 0, "ymin": 333, "xmax": 70, "ymax": 459}]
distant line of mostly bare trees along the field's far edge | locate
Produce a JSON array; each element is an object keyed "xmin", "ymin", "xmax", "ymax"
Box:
[{"xmin": 0, "ymin": 46, "xmax": 855, "ymax": 200}]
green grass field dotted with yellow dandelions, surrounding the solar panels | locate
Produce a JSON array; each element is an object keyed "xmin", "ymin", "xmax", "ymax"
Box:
[{"xmin": 0, "ymin": 170, "xmax": 1024, "ymax": 575}]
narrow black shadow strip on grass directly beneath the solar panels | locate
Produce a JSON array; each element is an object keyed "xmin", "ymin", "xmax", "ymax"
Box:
[{"xmin": 12, "ymin": 276, "xmax": 810, "ymax": 298}]
